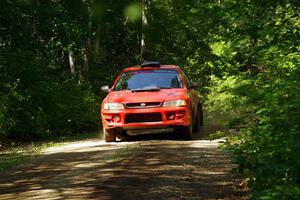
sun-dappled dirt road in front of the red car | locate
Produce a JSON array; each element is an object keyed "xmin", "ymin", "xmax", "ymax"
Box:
[{"xmin": 0, "ymin": 132, "xmax": 247, "ymax": 200}]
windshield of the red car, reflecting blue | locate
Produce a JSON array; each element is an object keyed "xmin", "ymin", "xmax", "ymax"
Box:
[{"xmin": 114, "ymin": 69, "xmax": 183, "ymax": 91}]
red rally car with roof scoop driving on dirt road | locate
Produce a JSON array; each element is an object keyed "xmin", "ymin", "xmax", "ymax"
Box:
[{"xmin": 101, "ymin": 62, "xmax": 203, "ymax": 142}]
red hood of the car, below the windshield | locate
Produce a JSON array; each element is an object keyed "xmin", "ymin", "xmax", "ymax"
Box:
[{"xmin": 106, "ymin": 89, "xmax": 186, "ymax": 103}]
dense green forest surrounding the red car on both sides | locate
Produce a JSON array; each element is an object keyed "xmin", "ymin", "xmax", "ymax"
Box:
[{"xmin": 0, "ymin": 0, "xmax": 300, "ymax": 199}]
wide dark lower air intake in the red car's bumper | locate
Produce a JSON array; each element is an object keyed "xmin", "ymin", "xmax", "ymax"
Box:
[{"xmin": 125, "ymin": 113, "xmax": 162, "ymax": 124}]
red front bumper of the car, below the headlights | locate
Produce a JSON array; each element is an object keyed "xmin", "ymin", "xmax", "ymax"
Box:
[{"xmin": 101, "ymin": 107, "xmax": 191, "ymax": 130}]
